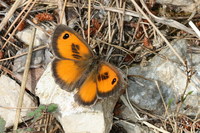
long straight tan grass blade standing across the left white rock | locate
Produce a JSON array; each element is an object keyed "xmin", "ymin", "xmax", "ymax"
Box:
[{"xmin": 13, "ymin": 28, "xmax": 36, "ymax": 131}]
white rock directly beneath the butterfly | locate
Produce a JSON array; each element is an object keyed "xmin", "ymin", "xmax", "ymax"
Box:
[{"xmin": 36, "ymin": 63, "xmax": 119, "ymax": 133}]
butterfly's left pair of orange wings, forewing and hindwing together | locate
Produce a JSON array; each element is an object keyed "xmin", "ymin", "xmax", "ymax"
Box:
[{"xmin": 52, "ymin": 25, "xmax": 94, "ymax": 91}]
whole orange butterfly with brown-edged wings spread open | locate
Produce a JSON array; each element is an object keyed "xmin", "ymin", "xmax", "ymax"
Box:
[{"xmin": 52, "ymin": 25, "xmax": 122, "ymax": 105}]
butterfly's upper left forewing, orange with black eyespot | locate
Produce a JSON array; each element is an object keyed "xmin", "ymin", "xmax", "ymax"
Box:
[{"xmin": 52, "ymin": 25, "xmax": 93, "ymax": 61}]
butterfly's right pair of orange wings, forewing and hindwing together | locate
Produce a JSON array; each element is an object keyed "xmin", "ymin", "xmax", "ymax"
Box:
[{"xmin": 75, "ymin": 62, "xmax": 122, "ymax": 105}]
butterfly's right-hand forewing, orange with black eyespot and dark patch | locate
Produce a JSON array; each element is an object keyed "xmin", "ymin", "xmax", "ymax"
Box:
[{"xmin": 96, "ymin": 62, "xmax": 122, "ymax": 98}]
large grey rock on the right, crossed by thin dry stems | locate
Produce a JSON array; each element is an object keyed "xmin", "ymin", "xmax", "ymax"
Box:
[{"xmin": 128, "ymin": 39, "xmax": 200, "ymax": 115}]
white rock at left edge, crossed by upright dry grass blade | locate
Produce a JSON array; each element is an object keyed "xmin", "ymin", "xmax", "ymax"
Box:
[{"xmin": 0, "ymin": 75, "xmax": 34, "ymax": 127}]
